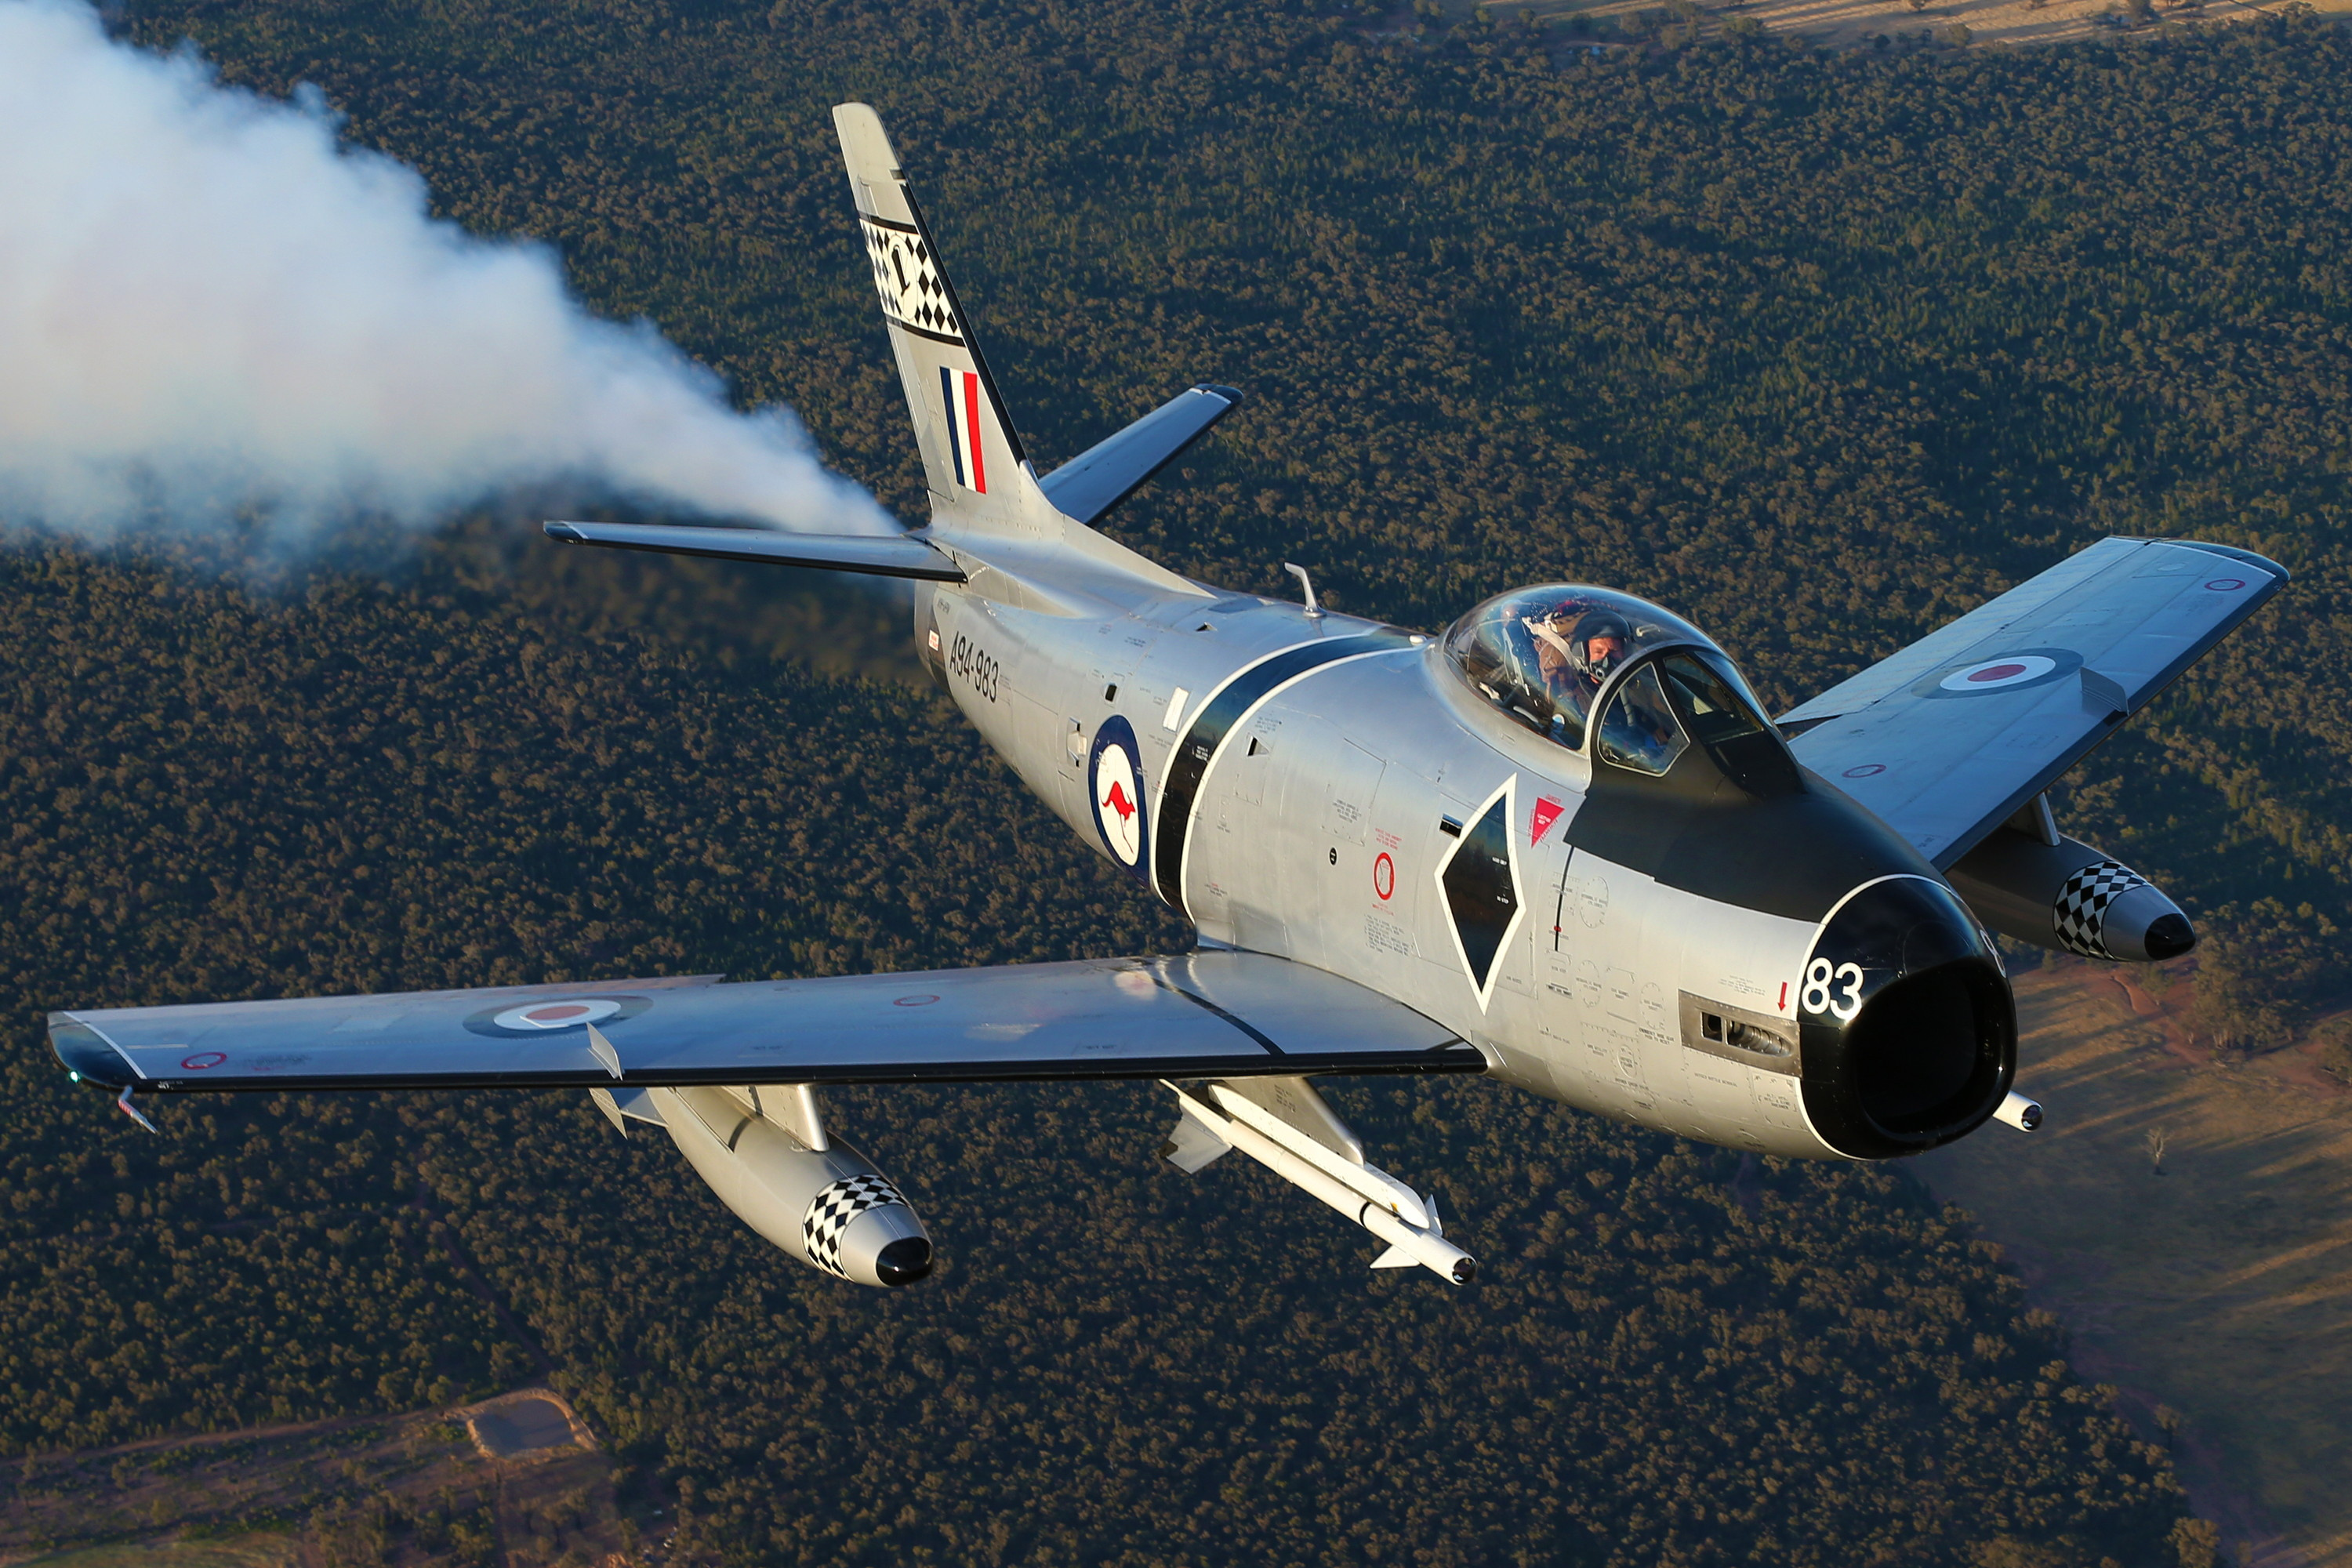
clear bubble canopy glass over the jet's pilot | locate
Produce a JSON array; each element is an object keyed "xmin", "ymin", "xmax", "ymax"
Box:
[{"xmin": 1444, "ymin": 583, "xmax": 1755, "ymax": 748}]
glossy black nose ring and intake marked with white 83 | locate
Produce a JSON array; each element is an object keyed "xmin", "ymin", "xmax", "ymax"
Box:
[{"xmin": 1797, "ymin": 877, "xmax": 2018, "ymax": 1159}]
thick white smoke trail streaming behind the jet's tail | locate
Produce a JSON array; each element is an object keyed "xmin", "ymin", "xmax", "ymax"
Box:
[{"xmin": 0, "ymin": 0, "xmax": 896, "ymax": 550}]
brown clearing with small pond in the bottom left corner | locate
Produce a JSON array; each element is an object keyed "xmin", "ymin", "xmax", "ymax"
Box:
[{"xmin": 0, "ymin": 1396, "xmax": 670, "ymax": 1568}]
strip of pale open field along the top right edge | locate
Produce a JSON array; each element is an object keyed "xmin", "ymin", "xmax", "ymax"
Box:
[{"xmin": 1486, "ymin": 0, "xmax": 2352, "ymax": 47}]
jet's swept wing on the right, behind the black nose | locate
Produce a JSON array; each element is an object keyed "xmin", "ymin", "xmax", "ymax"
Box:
[{"xmin": 1780, "ymin": 539, "xmax": 2286, "ymax": 869}]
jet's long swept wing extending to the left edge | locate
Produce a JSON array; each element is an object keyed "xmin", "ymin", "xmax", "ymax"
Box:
[{"xmin": 49, "ymin": 952, "xmax": 1484, "ymax": 1093}]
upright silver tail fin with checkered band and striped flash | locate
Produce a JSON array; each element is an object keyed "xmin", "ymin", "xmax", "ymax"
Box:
[{"xmin": 833, "ymin": 103, "xmax": 1207, "ymax": 593}]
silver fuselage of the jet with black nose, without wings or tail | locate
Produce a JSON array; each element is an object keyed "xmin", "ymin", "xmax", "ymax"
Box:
[{"xmin": 915, "ymin": 564, "xmax": 2016, "ymax": 1159}]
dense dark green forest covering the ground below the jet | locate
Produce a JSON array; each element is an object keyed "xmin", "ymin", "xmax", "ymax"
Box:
[{"xmin": 0, "ymin": 0, "xmax": 2352, "ymax": 1568}]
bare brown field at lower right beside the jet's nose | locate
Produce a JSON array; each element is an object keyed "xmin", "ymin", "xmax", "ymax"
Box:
[{"xmin": 1919, "ymin": 964, "xmax": 2352, "ymax": 1568}]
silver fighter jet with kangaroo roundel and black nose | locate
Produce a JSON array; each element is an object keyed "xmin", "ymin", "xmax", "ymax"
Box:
[{"xmin": 49, "ymin": 103, "xmax": 2286, "ymax": 1286}]
